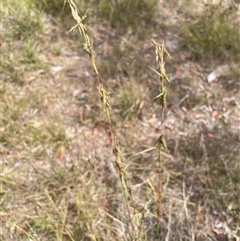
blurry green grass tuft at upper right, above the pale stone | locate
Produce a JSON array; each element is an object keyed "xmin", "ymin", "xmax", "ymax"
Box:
[{"xmin": 182, "ymin": 4, "xmax": 240, "ymax": 62}]
